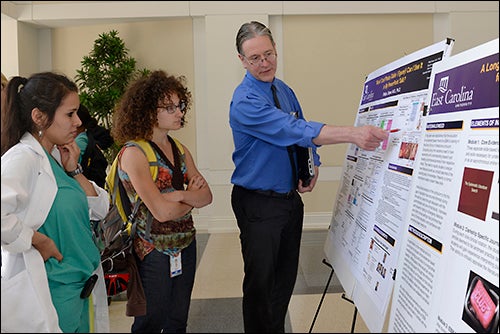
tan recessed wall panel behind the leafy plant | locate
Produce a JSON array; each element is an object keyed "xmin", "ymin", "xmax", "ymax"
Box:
[{"xmin": 52, "ymin": 18, "xmax": 196, "ymax": 154}]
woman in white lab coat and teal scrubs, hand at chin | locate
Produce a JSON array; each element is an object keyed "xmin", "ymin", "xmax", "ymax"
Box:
[{"xmin": 1, "ymin": 72, "xmax": 109, "ymax": 333}]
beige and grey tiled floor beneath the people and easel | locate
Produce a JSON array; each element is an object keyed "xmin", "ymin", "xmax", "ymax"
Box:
[{"xmin": 109, "ymin": 230, "xmax": 368, "ymax": 333}]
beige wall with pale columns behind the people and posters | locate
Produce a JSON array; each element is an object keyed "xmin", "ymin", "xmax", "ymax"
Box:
[{"xmin": 2, "ymin": 1, "xmax": 498, "ymax": 232}]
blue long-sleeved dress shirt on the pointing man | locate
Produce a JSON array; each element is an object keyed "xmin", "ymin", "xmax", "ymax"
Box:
[{"xmin": 229, "ymin": 71, "xmax": 324, "ymax": 193}]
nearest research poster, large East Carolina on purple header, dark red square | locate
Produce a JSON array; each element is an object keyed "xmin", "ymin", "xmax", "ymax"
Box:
[{"xmin": 389, "ymin": 39, "xmax": 500, "ymax": 333}]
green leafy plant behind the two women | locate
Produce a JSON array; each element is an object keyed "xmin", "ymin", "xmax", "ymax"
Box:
[{"xmin": 75, "ymin": 30, "xmax": 150, "ymax": 161}]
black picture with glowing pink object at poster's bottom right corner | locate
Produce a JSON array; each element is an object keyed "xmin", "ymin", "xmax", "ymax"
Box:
[{"xmin": 462, "ymin": 271, "xmax": 499, "ymax": 333}]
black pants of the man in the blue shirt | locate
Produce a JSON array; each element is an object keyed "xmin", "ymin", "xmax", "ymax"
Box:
[{"xmin": 231, "ymin": 186, "xmax": 304, "ymax": 333}]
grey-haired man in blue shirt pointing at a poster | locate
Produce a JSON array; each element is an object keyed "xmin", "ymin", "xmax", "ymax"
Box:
[{"xmin": 229, "ymin": 21, "xmax": 388, "ymax": 333}]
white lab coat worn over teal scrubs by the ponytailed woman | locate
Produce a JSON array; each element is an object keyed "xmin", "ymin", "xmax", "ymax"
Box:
[{"xmin": 1, "ymin": 133, "xmax": 109, "ymax": 333}]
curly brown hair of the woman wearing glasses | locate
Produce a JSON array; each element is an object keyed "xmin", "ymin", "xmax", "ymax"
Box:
[{"xmin": 111, "ymin": 70, "xmax": 192, "ymax": 144}]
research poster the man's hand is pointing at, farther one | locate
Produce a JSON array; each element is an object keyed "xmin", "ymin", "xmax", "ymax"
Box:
[{"xmin": 324, "ymin": 39, "xmax": 453, "ymax": 332}]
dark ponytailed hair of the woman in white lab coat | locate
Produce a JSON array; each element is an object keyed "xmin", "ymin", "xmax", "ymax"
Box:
[{"xmin": 1, "ymin": 72, "xmax": 78, "ymax": 155}]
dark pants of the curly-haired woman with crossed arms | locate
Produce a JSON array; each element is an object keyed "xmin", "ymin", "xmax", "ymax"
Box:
[{"xmin": 132, "ymin": 239, "xmax": 196, "ymax": 333}]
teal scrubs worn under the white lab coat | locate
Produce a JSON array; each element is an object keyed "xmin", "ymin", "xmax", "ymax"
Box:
[{"xmin": 38, "ymin": 152, "xmax": 100, "ymax": 333}]
